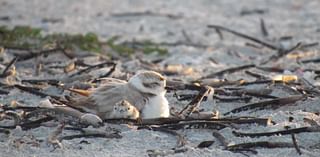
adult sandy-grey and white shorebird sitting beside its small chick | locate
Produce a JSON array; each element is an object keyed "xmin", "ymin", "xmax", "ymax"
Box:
[{"xmin": 70, "ymin": 71, "xmax": 170, "ymax": 119}]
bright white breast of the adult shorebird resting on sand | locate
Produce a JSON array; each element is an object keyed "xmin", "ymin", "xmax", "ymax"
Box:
[{"xmin": 142, "ymin": 92, "xmax": 170, "ymax": 119}]
